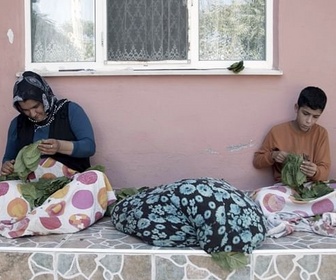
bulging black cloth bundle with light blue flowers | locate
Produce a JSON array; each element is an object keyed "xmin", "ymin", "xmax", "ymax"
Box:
[{"xmin": 111, "ymin": 178, "xmax": 266, "ymax": 253}]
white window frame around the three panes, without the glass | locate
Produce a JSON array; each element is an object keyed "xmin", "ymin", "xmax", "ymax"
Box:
[{"xmin": 25, "ymin": 0, "xmax": 276, "ymax": 75}]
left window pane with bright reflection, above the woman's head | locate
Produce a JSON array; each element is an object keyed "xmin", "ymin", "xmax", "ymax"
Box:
[{"xmin": 31, "ymin": 0, "xmax": 95, "ymax": 62}]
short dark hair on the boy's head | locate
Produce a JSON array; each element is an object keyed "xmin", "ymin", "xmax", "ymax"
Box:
[{"xmin": 297, "ymin": 86, "xmax": 327, "ymax": 111}]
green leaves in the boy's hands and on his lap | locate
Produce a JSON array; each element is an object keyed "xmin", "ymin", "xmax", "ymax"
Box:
[{"xmin": 281, "ymin": 154, "xmax": 333, "ymax": 201}]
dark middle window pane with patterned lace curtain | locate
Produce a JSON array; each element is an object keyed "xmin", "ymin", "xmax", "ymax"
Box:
[{"xmin": 107, "ymin": 0, "xmax": 188, "ymax": 61}]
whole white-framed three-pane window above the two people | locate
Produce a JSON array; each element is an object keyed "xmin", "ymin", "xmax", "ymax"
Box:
[{"xmin": 26, "ymin": 0, "xmax": 273, "ymax": 71}]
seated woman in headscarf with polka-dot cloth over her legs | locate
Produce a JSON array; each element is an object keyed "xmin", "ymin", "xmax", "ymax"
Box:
[{"xmin": 0, "ymin": 71, "xmax": 115, "ymax": 238}]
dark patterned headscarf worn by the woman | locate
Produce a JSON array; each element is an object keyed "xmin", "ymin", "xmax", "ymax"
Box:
[{"xmin": 13, "ymin": 71, "xmax": 65, "ymax": 126}]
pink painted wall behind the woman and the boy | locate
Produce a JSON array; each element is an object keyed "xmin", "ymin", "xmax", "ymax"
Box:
[{"xmin": 0, "ymin": 0, "xmax": 336, "ymax": 189}]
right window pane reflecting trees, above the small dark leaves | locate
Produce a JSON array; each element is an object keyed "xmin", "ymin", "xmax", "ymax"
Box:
[{"xmin": 199, "ymin": 0, "xmax": 266, "ymax": 61}]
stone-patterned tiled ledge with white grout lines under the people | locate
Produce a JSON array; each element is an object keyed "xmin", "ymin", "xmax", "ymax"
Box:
[{"xmin": 0, "ymin": 218, "xmax": 336, "ymax": 280}]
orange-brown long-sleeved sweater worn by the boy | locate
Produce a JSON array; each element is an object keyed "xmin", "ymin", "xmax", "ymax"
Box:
[{"xmin": 253, "ymin": 122, "xmax": 331, "ymax": 182}]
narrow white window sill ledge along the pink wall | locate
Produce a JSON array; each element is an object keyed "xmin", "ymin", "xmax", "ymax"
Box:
[{"xmin": 17, "ymin": 68, "xmax": 283, "ymax": 77}]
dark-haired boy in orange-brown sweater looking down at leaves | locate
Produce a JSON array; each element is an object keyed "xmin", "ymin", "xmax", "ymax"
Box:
[{"xmin": 253, "ymin": 86, "xmax": 331, "ymax": 182}]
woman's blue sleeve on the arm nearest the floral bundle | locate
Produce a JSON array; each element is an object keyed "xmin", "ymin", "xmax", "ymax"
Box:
[{"xmin": 69, "ymin": 102, "xmax": 96, "ymax": 157}]
